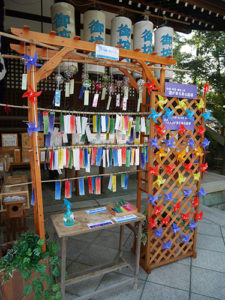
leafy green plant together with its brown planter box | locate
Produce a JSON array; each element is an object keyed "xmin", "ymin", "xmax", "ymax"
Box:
[{"xmin": 0, "ymin": 232, "xmax": 61, "ymax": 300}]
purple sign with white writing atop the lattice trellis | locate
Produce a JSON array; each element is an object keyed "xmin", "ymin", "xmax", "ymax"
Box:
[{"xmin": 165, "ymin": 82, "xmax": 197, "ymax": 99}]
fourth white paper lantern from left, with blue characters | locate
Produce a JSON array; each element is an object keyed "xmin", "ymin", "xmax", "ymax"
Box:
[{"xmin": 133, "ymin": 20, "xmax": 153, "ymax": 78}]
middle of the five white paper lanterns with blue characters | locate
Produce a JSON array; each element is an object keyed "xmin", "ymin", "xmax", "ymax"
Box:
[{"xmin": 111, "ymin": 16, "xmax": 132, "ymax": 75}]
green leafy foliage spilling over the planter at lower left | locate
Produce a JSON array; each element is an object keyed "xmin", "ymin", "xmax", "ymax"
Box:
[{"xmin": 0, "ymin": 232, "xmax": 61, "ymax": 300}]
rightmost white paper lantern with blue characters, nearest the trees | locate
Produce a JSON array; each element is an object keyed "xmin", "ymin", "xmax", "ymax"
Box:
[{"xmin": 155, "ymin": 26, "xmax": 174, "ymax": 79}]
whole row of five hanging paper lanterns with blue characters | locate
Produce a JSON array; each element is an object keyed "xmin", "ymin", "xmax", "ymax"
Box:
[{"xmin": 52, "ymin": 2, "xmax": 174, "ymax": 79}]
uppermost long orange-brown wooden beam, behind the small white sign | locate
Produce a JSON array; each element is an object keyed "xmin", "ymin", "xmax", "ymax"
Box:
[{"xmin": 11, "ymin": 28, "xmax": 176, "ymax": 65}]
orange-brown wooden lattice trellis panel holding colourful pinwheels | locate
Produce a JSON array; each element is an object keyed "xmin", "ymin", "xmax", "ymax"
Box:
[{"xmin": 139, "ymin": 92, "xmax": 205, "ymax": 272}]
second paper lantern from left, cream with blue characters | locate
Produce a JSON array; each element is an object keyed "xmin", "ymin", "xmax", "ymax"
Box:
[{"xmin": 83, "ymin": 10, "xmax": 105, "ymax": 75}]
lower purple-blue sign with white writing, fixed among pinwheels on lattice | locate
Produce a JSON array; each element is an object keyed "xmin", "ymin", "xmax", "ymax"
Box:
[{"xmin": 163, "ymin": 116, "xmax": 194, "ymax": 130}]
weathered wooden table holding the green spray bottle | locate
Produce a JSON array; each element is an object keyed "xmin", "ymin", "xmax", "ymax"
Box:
[{"xmin": 51, "ymin": 210, "xmax": 145, "ymax": 300}]
